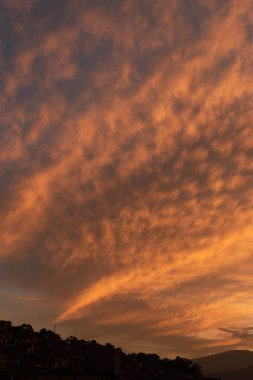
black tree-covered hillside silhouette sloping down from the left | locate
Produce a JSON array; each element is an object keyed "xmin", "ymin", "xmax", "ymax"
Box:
[{"xmin": 0, "ymin": 321, "xmax": 219, "ymax": 380}]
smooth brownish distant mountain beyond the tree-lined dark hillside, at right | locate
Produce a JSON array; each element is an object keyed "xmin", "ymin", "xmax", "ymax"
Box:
[{"xmin": 192, "ymin": 350, "xmax": 253, "ymax": 380}]
